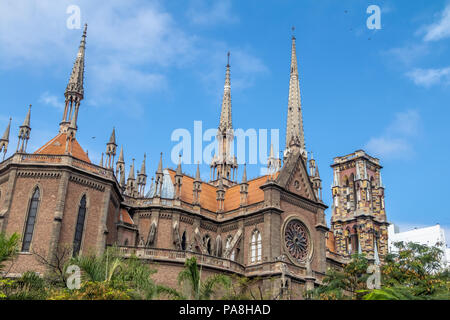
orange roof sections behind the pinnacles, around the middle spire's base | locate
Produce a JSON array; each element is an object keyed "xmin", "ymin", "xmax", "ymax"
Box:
[{"xmin": 168, "ymin": 169, "xmax": 267, "ymax": 212}]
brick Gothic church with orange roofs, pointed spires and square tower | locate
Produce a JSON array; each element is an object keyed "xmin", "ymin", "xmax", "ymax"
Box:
[{"xmin": 0, "ymin": 26, "xmax": 387, "ymax": 298}]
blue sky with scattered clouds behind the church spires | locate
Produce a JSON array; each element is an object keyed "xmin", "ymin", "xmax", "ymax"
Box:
[{"xmin": 0, "ymin": 0, "xmax": 450, "ymax": 239}]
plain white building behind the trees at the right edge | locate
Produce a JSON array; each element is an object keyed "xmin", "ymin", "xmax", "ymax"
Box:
[{"xmin": 388, "ymin": 224, "xmax": 450, "ymax": 267}]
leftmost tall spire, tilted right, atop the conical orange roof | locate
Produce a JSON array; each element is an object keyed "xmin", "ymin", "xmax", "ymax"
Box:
[{"xmin": 59, "ymin": 24, "xmax": 87, "ymax": 133}]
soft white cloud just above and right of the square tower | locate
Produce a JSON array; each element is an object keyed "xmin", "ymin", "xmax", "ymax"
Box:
[{"xmin": 365, "ymin": 110, "xmax": 420, "ymax": 159}]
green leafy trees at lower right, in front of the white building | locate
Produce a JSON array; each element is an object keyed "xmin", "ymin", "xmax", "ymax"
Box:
[{"xmin": 307, "ymin": 242, "xmax": 450, "ymax": 300}]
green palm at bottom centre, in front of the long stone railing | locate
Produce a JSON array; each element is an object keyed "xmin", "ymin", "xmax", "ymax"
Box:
[{"xmin": 158, "ymin": 257, "xmax": 231, "ymax": 300}]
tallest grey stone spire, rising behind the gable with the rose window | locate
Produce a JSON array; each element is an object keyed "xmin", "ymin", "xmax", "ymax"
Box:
[{"xmin": 286, "ymin": 30, "xmax": 307, "ymax": 158}]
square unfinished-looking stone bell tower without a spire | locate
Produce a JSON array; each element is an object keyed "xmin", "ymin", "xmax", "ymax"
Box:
[{"xmin": 331, "ymin": 150, "xmax": 388, "ymax": 260}]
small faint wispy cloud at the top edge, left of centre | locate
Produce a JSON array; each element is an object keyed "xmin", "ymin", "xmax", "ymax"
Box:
[{"xmin": 186, "ymin": 0, "xmax": 239, "ymax": 26}]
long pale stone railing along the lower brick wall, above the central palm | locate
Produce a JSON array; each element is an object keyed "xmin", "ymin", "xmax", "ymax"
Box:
[{"xmin": 119, "ymin": 247, "xmax": 245, "ymax": 274}]
